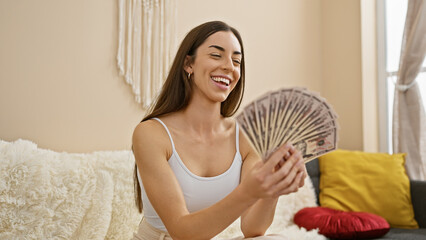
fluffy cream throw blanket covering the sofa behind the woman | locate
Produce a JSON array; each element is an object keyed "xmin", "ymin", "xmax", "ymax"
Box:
[{"xmin": 0, "ymin": 140, "xmax": 325, "ymax": 240}]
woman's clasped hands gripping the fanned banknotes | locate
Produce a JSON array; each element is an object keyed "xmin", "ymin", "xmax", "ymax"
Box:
[{"xmin": 241, "ymin": 143, "xmax": 306, "ymax": 199}]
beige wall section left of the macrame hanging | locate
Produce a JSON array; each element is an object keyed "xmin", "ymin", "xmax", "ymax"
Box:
[{"xmin": 0, "ymin": 0, "xmax": 142, "ymax": 152}]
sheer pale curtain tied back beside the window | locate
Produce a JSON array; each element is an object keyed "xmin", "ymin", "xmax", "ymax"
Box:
[{"xmin": 393, "ymin": 0, "xmax": 426, "ymax": 180}]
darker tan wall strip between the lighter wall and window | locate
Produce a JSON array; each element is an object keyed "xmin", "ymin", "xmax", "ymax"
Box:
[{"xmin": 321, "ymin": 0, "xmax": 363, "ymax": 150}]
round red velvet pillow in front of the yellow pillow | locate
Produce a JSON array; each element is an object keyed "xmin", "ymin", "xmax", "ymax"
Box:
[{"xmin": 294, "ymin": 207, "xmax": 390, "ymax": 239}]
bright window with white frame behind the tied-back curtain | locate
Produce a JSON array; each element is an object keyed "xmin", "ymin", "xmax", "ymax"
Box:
[{"xmin": 377, "ymin": 0, "xmax": 426, "ymax": 153}]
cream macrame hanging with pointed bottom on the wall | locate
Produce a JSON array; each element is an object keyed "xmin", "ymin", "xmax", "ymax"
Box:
[{"xmin": 117, "ymin": 0, "xmax": 176, "ymax": 108}]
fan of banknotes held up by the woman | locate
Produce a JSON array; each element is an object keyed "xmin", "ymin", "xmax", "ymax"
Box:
[{"xmin": 236, "ymin": 88, "xmax": 339, "ymax": 162}]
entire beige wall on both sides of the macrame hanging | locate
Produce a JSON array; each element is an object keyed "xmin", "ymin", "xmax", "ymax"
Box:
[{"xmin": 0, "ymin": 0, "xmax": 362, "ymax": 152}]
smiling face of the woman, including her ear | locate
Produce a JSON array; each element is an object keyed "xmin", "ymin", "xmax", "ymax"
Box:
[{"xmin": 185, "ymin": 31, "xmax": 242, "ymax": 102}]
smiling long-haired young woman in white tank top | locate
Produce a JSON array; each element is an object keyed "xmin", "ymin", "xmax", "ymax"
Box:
[{"xmin": 133, "ymin": 21, "xmax": 306, "ymax": 240}]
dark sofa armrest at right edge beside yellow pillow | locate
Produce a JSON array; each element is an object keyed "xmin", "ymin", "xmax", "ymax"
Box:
[{"xmin": 410, "ymin": 180, "xmax": 426, "ymax": 228}]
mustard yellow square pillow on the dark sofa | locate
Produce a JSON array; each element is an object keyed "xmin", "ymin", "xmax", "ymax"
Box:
[{"xmin": 319, "ymin": 150, "xmax": 419, "ymax": 228}]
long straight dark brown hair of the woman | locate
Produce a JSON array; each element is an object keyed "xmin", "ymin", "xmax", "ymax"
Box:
[{"xmin": 134, "ymin": 21, "xmax": 245, "ymax": 212}]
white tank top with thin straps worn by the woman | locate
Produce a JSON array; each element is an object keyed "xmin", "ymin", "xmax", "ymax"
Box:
[{"xmin": 137, "ymin": 118, "xmax": 242, "ymax": 231}]
